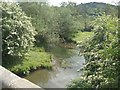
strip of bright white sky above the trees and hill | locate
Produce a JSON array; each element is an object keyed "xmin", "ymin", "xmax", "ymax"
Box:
[{"xmin": 48, "ymin": 0, "xmax": 119, "ymax": 6}]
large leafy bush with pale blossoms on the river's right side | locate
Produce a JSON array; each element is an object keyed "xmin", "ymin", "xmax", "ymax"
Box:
[{"xmin": 70, "ymin": 15, "xmax": 120, "ymax": 88}]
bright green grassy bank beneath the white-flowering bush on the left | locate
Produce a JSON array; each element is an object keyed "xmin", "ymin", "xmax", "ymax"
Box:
[{"xmin": 8, "ymin": 48, "xmax": 52, "ymax": 75}]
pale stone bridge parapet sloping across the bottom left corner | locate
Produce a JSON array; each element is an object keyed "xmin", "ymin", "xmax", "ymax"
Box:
[{"xmin": 0, "ymin": 65, "xmax": 43, "ymax": 90}]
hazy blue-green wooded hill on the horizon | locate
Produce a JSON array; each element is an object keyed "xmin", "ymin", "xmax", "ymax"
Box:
[{"xmin": 77, "ymin": 2, "xmax": 118, "ymax": 16}]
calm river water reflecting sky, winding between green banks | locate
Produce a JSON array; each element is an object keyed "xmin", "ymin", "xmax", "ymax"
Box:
[{"xmin": 24, "ymin": 47, "xmax": 85, "ymax": 88}]
